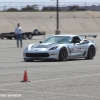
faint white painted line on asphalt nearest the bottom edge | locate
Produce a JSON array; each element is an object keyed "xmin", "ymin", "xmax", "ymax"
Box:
[{"xmin": 0, "ymin": 89, "xmax": 100, "ymax": 99}]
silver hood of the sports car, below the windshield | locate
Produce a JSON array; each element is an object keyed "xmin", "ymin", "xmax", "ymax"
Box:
[{"xmin": 31, "ymin": 43, "xmax": 58, "ymax": 49}]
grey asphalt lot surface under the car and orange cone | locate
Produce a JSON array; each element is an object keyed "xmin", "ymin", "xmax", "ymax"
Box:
[{"xmin": 0, "ymin": 33, "xmax": 100, "ymax": 100}]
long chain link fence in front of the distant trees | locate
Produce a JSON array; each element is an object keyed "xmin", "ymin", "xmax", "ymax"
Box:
[{"xmin": 0, "ymin": 2, "xmax": 100, "ymax": 11}]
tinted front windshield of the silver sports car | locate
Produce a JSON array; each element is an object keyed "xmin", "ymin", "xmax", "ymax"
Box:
[{"xmin": 43, "ymin": 36, "xmax": 71, "ymax": 44}]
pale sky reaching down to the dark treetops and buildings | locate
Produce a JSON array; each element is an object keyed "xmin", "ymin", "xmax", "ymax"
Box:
[{"xmin": 0, "ymin": 0, "xmax": 100, "ymax": 10}]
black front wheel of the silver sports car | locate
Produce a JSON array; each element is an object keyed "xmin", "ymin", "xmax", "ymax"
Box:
[{"xmin": 59, "ymin": 47, "xmax": 68, "ymax": 61}]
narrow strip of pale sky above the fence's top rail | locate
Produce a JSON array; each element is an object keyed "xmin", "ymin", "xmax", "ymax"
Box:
[{"xmin": 0, "ymin": 0, "xmax": 100, "ymax": 3}]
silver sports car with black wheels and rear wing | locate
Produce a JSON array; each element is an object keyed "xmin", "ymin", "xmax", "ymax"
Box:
[{"xmin": 23, "ymin": 35, "xmax": 97, "ymax": 61}]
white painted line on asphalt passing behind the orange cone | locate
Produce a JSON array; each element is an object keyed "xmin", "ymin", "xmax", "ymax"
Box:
[{"xmin": 0, "ymin": 74, "xmax": 100, "ymax": 87}]
